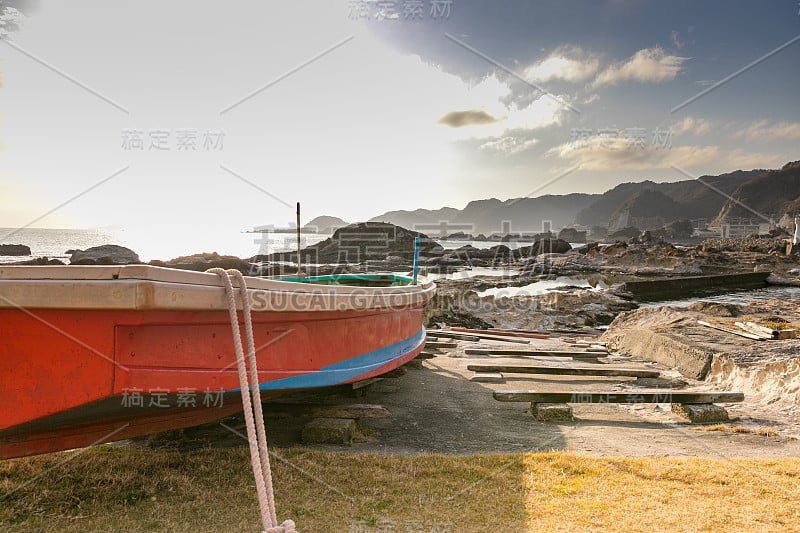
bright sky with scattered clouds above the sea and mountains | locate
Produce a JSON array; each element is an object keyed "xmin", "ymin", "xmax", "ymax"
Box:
[{"xmin": 0, "ymin": 0, "xmax": 800, "ymax": 248}]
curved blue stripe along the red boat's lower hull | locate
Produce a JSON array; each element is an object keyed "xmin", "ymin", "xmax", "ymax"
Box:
[{"xmin": 228, "ymin": 327, "xmax": 425, "ymax": 392}]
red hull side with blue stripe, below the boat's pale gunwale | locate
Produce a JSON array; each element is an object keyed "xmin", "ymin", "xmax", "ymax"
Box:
[{"xmin": 0, "ymin": 266, "xmax": 434, "ymax": 459}]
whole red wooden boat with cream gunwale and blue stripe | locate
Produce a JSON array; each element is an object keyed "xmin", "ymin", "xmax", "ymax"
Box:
[{"xmin": 0, "ymin": 265, "xmax": 435, "ymax": 459}]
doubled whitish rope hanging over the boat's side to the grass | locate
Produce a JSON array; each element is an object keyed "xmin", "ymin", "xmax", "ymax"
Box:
[{"xmin": 208, "ymin": 268, "xmax": 296, "ymax": 533}]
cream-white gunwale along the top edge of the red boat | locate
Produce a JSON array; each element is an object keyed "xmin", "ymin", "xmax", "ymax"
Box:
[{"xmin": 0, "ymin": 265, "xmax": 435, "ymax": 312}]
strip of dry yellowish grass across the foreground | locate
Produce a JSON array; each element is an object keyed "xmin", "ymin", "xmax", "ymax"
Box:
[{"xmin": 0, "ymin": 448, "xmax": 800, "ymax": 533}]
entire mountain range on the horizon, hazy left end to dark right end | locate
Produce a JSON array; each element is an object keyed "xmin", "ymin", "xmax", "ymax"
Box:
[{"xmin": 318, "ymin": 161, "xmax": 800, "ymax": 236}]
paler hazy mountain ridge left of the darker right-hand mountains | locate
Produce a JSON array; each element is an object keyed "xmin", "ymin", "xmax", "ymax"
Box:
[{"xmin": 370, "ymin": 193, "xmax": 599, "ymax": 235}]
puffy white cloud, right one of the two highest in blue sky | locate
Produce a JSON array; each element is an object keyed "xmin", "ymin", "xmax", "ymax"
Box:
[{"xmin": 593, "ymin": 46, "xmax": 689, "ymax": 87}]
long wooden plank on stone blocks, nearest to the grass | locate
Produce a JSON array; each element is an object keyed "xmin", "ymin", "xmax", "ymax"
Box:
[{"xmin": 494, "ymin": 389, "xmax": 744, "ymax": 403}]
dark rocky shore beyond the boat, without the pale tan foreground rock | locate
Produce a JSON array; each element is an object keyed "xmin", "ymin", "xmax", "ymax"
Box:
[{"xmin": 6, "ymin": 222, "xmax": 800, "ymax": 329}]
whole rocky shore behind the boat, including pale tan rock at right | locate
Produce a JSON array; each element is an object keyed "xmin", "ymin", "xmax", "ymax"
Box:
[{"xmin": 6, "ymin": 223, "xmax": 800, "ymax": 435}]
